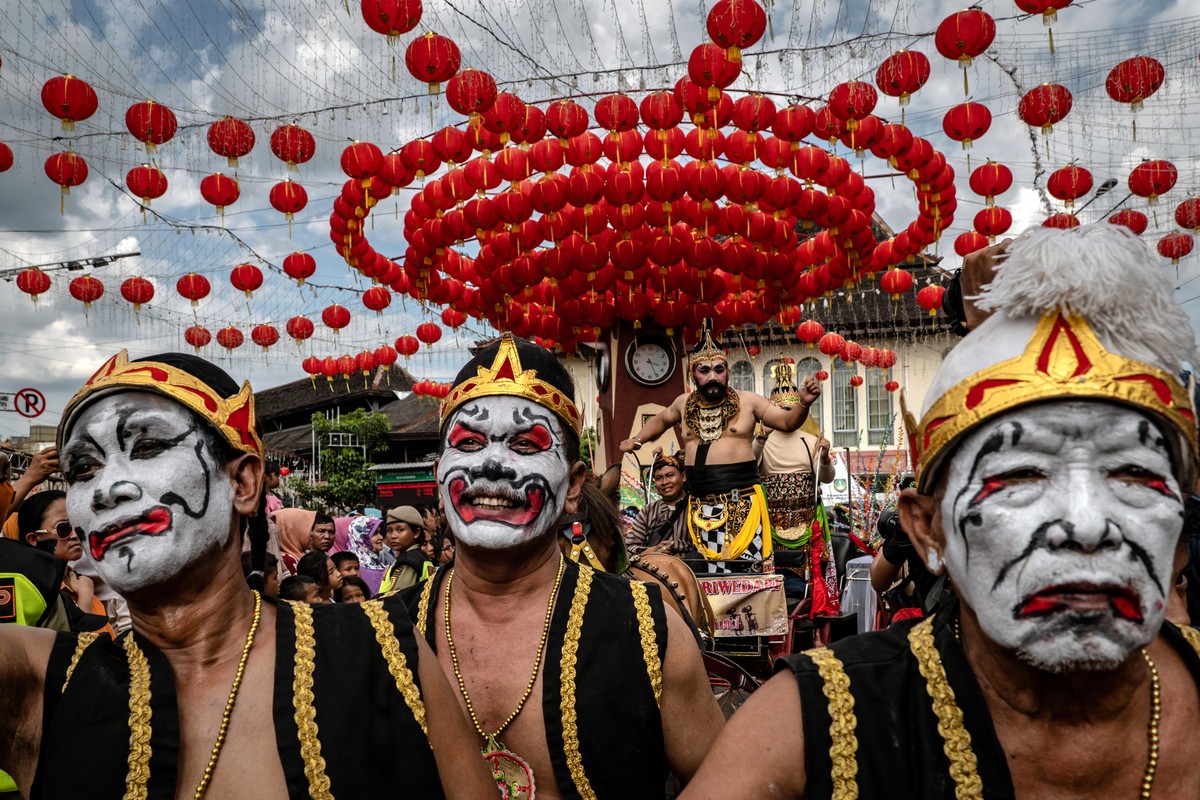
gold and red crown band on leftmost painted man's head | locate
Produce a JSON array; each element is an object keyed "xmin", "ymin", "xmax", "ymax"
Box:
[{"xmin": 59, "ymin": 350, "xmax": 265, "ymax": 456}]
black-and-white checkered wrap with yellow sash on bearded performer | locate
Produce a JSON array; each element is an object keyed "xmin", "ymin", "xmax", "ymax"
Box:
[{"xmin": 686, "ymin": 461, "xmax": 770, "ymax": 573}]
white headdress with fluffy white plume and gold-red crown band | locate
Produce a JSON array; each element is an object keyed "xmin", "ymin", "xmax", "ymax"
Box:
[{"xmin": 901, "ymin": 223, "xmax": 1200, "ymax": 493}]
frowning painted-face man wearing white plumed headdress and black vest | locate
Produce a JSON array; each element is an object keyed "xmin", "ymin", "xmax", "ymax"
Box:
[{"xmin": 684, "ymin": 223, "xmax": 1200, "ymax": 800}]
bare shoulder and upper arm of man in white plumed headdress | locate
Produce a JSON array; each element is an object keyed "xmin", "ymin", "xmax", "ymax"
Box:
[{"xmin": 680, "ymin": 670, "xmax": 805, "ymax": 800}]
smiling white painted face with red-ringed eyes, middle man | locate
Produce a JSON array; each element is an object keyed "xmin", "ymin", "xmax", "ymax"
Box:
[{"xmin": 438, "ymin": 397, "xmax": 571, "ymax": 549}]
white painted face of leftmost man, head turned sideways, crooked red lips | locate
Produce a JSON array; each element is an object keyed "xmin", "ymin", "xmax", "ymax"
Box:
[{"xmin": 62, "ymin": 392, "xmax": 234, "ymax": 594}]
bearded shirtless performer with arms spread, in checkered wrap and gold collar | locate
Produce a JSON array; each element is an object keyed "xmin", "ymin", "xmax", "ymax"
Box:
[{"xmin": 620, "ymin": 324, "xmax": 821, "ymax": 572}]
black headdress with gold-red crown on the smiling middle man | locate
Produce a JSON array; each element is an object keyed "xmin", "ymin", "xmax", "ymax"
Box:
[{"xmin": 442, "ymin": 333, "xmax": 581, "ymax": 437}]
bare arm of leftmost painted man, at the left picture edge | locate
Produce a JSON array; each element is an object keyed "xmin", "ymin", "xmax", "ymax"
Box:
[{"xmin": 0, "ymin": 625, "xmax": 55, "ymax": 798}]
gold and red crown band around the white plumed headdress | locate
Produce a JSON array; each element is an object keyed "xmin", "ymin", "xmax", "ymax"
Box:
[{"xmin": 905, "ymin": 312, "xmax": 1198, "ymax": 492}]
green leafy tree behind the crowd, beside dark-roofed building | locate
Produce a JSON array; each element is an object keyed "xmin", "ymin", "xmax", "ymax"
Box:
[{"xmin": 301, "ymin": 409, "xmax": 390, "ymax": 509}]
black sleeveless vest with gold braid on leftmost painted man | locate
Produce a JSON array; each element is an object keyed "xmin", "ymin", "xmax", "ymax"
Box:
[{"xmin": 32, "ymin": 601, "xmax": 444, "ymax": 800}]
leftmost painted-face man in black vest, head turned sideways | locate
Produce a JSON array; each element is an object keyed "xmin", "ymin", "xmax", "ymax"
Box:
[{"xmin": 0, "ymin": 351, "xmax": 494, "ymax": 800}]
